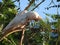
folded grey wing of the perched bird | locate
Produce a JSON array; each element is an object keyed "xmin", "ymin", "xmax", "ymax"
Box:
[{"xmin": 3, "ymin": 10, "xmax": 27, "ymax": 32}]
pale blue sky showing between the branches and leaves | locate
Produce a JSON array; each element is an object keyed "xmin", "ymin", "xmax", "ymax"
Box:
[{"xmin": 0, "ymin": 0, "xmax": 60, "ymax": 20}]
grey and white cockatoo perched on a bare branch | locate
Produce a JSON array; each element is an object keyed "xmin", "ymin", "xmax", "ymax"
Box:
[{"xmin": 2, "ymin": 10, "xmax": 41, "ymax": 41}]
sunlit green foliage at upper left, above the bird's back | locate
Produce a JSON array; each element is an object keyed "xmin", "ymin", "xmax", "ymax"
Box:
[{"xmin": 0, "ymin": 0, "xmax": 17, "ymax": 28}]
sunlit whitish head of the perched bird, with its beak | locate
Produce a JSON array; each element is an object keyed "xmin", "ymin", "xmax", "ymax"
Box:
[{"xmin": 27, "ymin": 11, "xmax": 42, "ymax": 21}]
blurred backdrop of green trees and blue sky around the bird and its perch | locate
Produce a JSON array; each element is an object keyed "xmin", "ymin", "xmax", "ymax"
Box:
[{"xmin": 0, "ymin": 0, "xmax": 60, "ymax": 45}]
